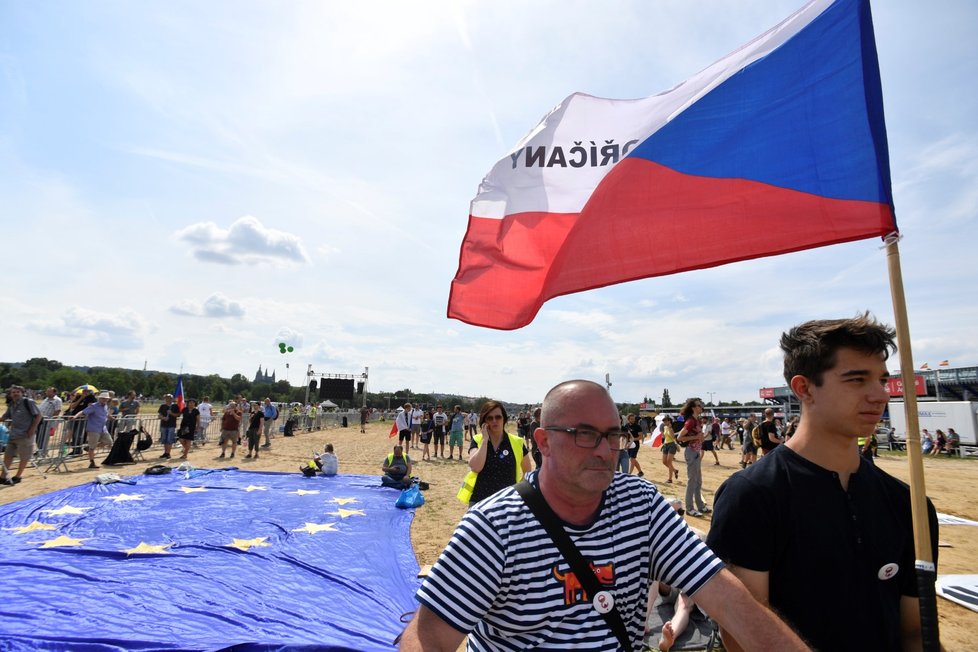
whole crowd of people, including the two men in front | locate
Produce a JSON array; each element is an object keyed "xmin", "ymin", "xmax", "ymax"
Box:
[{"xmin": 3, "ymin": 314, "xmax": 954, "ymax": 650}]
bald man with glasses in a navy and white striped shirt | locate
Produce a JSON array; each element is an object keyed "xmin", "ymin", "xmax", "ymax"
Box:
[{"xmin": 401, "ymin": 380, "xmax": 807, "ymax": 651}]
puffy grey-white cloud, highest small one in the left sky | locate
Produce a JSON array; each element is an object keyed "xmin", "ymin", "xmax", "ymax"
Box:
[{"xmin": 176, "ymin": 215, "xmax": 309, "ymax": 265}]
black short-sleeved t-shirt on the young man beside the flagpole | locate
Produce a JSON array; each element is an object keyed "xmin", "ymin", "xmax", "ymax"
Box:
[{"xmin": 707, "ymin": 446, "xmax": 937, "ymax": 651}]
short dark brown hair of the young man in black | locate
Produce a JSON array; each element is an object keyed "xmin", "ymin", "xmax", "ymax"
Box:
[{"xmin": 781, "ymin": 311, "xmax": 896, "ymax": 386}]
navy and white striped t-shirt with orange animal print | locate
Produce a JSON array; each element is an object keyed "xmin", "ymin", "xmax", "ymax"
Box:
[{"xmin": 417, "ymin": 472, "xmax": 723, "ymax": 650}]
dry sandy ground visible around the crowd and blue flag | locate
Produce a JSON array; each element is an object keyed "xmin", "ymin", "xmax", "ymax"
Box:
[{"xmin": 0, "ymin": 421, "xmax": 978, "ymax": 650}]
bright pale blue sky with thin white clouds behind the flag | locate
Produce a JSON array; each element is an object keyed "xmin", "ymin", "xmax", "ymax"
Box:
[{"xmin": 0, "ymin": 0, "xmax": 978, "ymax": 402}]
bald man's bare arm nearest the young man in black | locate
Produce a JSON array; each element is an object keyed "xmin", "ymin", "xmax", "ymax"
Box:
[{"xmin": 692, "ymin": 566, "xmax": 809, "ymax": 652}]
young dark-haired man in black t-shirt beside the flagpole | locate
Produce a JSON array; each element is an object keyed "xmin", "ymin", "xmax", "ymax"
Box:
[{"xmin": 707, "ymin": 313, "xmax": 937, "ymax": 651}]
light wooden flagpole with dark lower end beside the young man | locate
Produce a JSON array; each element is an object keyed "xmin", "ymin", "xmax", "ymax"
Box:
[{"xmin": 885, "ymin": 233, "xmax": 940, "ymax": 652}]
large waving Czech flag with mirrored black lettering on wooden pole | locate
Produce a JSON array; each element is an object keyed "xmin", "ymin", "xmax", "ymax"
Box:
[{"xmin": 448, "ymin": 0, "xmax": 897, "ymax": 329}]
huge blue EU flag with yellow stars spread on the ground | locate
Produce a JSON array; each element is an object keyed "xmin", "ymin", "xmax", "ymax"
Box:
[{"xmin": 0, "ymin": 469, "xmax": 419, "ymax": 651}]
